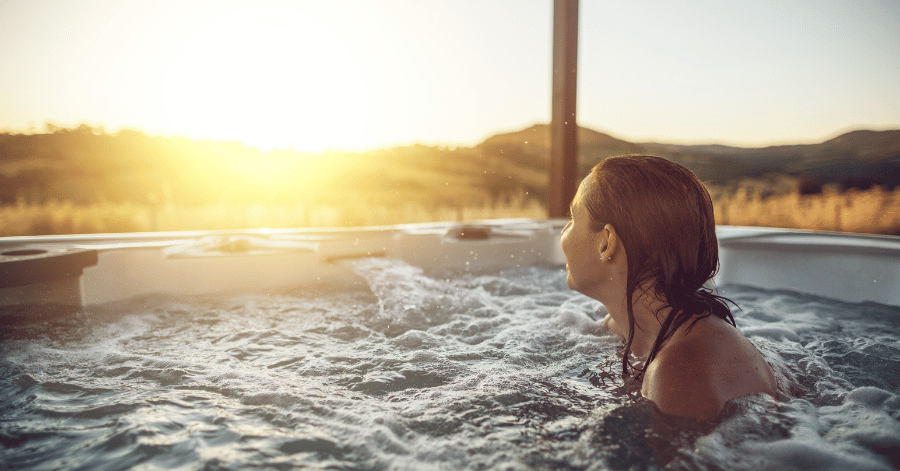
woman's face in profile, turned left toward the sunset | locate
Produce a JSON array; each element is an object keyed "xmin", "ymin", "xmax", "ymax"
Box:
[{"xmin": 561, "ymin": 179, "xmax": 602, "ymax": 298}]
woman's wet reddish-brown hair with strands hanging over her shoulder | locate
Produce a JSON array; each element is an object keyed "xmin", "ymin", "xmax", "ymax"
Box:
[{"xmin": 583, "ymin": 155, "xmax": 735, "ymax": 376}]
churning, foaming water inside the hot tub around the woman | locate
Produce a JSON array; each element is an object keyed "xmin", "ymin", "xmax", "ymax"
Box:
[{"xmin": 0, "ymin": 259, "xmax": 900, "ymax": 470}]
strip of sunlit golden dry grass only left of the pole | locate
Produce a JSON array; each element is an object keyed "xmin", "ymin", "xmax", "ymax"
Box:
[{"xmin": 0, "ymin": 194, "xmax": 547, "ymax": 236}]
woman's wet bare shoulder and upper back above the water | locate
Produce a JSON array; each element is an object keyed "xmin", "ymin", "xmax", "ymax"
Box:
[{"xmin": 641, "ymin": 318, "xmax": 775, "ymax": 418}]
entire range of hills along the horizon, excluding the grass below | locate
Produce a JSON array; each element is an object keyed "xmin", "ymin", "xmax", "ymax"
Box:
[{"xmin": 0, "ymin": 124, "xmax": 900, "ymax": 212}]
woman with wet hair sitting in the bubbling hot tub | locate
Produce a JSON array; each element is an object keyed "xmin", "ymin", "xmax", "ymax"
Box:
[{"xmin": 562, "ymin": 156, "xmax": 776, "ymax": 419}]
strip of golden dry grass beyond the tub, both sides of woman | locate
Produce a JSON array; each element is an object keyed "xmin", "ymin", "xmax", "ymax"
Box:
[{"xmin": 0, "ymin": 186, "xmax": 900, "ymax": 236}]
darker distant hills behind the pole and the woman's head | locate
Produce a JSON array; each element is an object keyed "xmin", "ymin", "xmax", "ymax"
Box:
[{"xmin": 477, "ymin": 124, "xmax": 900, "ymax": 188}]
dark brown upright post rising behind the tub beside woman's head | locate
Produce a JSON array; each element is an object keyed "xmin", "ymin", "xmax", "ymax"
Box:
[{"xmin": 547, "ymin": 0, "xmax": 578, "ymax": 217}]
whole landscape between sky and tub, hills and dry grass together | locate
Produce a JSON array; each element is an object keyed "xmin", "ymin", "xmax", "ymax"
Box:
[{"xmin": 0, "ymin": 125, "xmax": 900, "ymax": 236}]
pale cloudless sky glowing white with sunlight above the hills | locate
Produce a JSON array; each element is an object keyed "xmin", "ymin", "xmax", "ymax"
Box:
[{"xmin": 0, "ymin": 0, "xmax": 900, "ymax": 151}]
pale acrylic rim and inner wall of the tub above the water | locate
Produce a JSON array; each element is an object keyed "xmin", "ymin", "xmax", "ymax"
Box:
[{"xmin": 0, "ymin": 219, "xmax": 900, "ymax": 306}]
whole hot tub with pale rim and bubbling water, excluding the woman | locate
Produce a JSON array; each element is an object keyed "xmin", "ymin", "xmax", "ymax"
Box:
[{"xmin": 0, "ymin": 220, "xmax": 900, "ymax": 469}]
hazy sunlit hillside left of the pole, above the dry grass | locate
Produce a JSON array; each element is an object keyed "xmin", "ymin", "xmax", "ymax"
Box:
[{"xmin": 0, "ymin": 126, "xmax": 546, "ymax": 212}]
